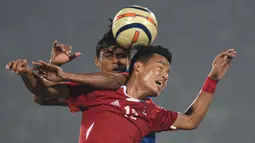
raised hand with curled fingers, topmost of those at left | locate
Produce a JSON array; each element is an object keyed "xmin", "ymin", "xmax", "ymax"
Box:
[{"xmin": 50, "ymin": 41, "xmax": 81, "ymax": 65}]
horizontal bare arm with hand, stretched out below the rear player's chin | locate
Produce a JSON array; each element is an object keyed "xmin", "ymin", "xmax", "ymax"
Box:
[{"xmin": 33, "ymin": 60, "xmax": 127, "ymax": 89}]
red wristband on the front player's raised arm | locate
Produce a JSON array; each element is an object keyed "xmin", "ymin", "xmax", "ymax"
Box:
[{"xmin": 202, "ymin": 77, "xmax": 218, "ymax": 93}]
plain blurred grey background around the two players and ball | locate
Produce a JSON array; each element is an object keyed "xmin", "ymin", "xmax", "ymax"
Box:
[{"xmin": 0, "ymin": 0, "xmax": 255, "ymax": 143}]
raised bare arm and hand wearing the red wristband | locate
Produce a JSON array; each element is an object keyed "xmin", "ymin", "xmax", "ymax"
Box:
[{"xmin": 173, "ymin": 49, "xmax": 236, "ymax": 130}]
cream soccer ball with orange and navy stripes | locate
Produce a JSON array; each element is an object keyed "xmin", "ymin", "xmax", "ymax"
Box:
[{"xmin": 112, "ymin": 5, "xmax": 158, "ymax": 48}]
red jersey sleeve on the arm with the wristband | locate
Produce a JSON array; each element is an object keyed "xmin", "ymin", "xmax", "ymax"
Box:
[{"xmin": 152, "ymin": 106, "xmax": 178, "ymax": 132}]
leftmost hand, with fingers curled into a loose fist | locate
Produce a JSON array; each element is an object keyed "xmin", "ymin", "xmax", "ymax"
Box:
[{"xmin": 5, "ymin": 59, "xmax": 32, "ymax": 76}]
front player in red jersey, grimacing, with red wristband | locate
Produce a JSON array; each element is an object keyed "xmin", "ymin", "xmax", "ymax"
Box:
[{"xmin": 27, "ymin": 46, "xmax": 236, "ymax": 143}]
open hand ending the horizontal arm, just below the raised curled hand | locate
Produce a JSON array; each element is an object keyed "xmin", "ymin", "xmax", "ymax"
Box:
[{"xmin": 32, "ymin": 60, "xmax": 64, "ymax": 82}]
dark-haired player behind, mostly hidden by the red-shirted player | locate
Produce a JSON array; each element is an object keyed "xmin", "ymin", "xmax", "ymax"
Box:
[{"xmin": 7, "ymin": 19, "xmax": 155, "ymax": 143}]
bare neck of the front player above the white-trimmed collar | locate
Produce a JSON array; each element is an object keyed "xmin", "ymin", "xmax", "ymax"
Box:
[{"xmin": 126, "ymin": 76, "xmax": 151, "ymax": 99}]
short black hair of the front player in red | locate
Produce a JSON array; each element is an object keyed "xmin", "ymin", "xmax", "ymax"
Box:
[{"xmin": 128, "ymin": 45, "xmax": 172, "ymax": 75}]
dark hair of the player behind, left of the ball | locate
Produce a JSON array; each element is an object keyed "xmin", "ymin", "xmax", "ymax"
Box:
[{"xmin": 96, "ymin": 19, "xmax": 130, "ymax": 58}]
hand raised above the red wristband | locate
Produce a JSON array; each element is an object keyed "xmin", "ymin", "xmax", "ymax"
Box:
[{"xmin": 209, "ymin": 49, "xmax": 236, "ymax": 80}]
